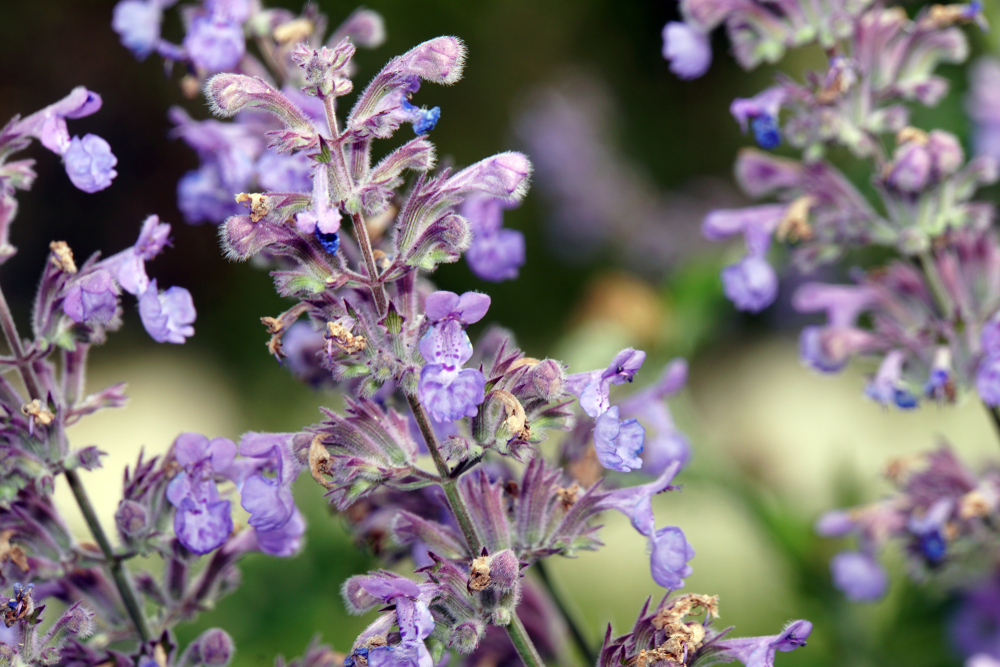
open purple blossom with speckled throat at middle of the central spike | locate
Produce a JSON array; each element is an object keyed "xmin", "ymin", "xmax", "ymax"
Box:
[{"xmin": 417, "ymin": 292, "xmax": 490, "ymax": 422}]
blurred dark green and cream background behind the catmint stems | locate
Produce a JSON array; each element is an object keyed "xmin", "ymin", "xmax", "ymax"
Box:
[{"xmin": 0, "ymin": 0, "xmax": 996, "ymax": 667}]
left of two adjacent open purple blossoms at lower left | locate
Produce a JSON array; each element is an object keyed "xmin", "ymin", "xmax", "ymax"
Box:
[{"xmin": 167, "ymin": 433, "xmax": 236, "ymax": 554}]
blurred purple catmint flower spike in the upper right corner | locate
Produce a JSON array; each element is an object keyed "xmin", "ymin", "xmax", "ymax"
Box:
[{"xmin": 668, "ymin": 0, "xmax": 1000, "ymax": 408}]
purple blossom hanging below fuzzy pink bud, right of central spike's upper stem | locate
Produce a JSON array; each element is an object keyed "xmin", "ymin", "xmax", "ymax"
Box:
[{"xmin": 460, "ymin": 193, "xmax": 524, "ymax": 282}]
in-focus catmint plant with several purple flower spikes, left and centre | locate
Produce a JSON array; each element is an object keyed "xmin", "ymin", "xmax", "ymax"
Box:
[{"xmin": 0, "ymin": 0, "xmax": 824, "ymax": 667}]
